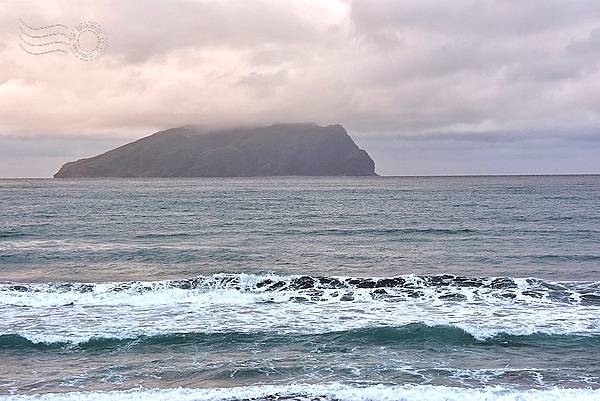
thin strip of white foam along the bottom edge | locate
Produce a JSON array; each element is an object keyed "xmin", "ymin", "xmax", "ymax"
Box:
[{"xmin": 0, "ymin": 384, "xmax": 600, "ymax": 401}]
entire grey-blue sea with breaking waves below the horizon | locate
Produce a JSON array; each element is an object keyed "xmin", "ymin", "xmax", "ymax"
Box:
[{"xmin": 0, "ymin": 176, "xmax": 600, "ymax": 401}]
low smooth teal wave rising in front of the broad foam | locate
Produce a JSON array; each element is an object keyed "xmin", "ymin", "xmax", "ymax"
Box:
[{"xmin": 0, "ymin": 323, "xmax": 600, "ymax": 350}]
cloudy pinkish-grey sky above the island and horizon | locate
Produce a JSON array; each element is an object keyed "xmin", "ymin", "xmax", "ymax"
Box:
[{"xmin": 0, "ymin": 0, "xmax": 600, "ymax": 177}]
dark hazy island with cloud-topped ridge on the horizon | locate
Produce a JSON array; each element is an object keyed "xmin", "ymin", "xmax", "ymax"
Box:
[{"xmin": 54, "ymin": 124, "xmax": 376, "ymax": 178}]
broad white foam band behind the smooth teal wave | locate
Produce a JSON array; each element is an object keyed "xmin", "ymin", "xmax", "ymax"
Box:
[{"xmin": 0, "ymin": 274, "xmax": 600, "ymax": 343}]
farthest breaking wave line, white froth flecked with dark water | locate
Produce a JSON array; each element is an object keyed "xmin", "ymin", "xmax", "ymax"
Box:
[{"xmin": 0, "ymin": 274, "xmax": 600, "ymax": 307}]
